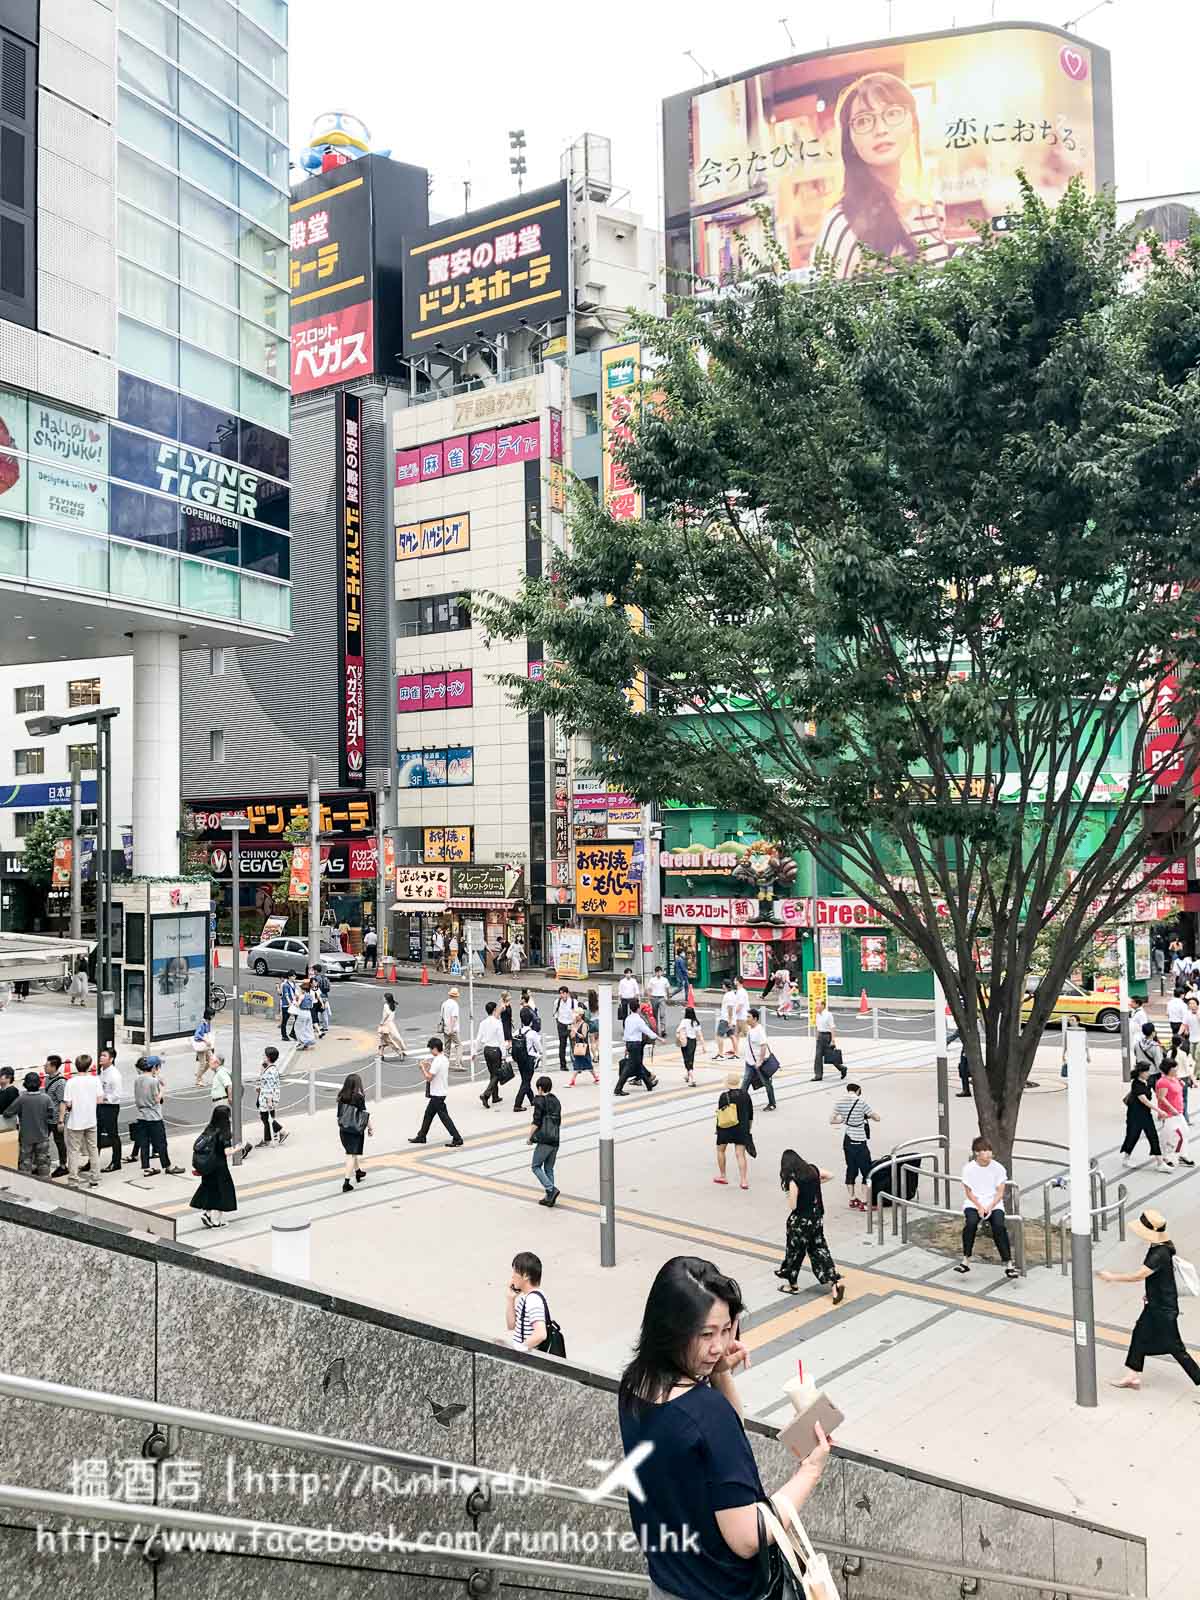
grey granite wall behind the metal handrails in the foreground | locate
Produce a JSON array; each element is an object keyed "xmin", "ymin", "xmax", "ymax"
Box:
[{"xmin": 0, "ymin": 1198, "xmax": 1146, "ymax": 1600}]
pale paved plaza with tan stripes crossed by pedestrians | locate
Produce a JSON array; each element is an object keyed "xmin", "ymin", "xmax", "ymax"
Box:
[{"xmin": 0, "ymin": 990, "xmax": 1200, "ymax": 1600}]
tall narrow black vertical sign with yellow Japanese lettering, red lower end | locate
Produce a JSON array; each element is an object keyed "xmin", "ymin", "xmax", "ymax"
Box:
[{"xmin": 338, "ymin": 392, "xmax": 366, "ymax": 789}]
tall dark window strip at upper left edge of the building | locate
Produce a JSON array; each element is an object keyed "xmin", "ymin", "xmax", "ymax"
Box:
[{"xmin": 0, "ymin": 30, "xmax": 37, "ymax": 328}]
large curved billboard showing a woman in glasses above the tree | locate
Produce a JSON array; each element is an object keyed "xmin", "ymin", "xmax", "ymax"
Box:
[{"xmin": 662, "ymin": 22, "xmax": 1114, "ymax": 288}]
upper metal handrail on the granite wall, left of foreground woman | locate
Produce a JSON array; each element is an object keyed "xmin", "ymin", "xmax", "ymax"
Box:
[{"xmin": 0, "ymin": 1373, "xmax": 626, "ymax": 1510}]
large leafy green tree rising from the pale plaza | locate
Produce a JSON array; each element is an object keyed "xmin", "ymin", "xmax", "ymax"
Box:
[{"xmin": 475, "ymin": 186, "xmax": 1200, "ymax": 1152}]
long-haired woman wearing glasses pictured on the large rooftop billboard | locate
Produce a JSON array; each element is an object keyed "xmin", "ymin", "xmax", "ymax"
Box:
[{"xmin": 814, "ymin": 72, "xmax": 950, "ymax": 278}]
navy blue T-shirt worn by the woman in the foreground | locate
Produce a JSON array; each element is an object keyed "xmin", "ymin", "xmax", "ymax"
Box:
[{"xmin": 619, "ymin": 1384, "xmax": 766, "ymax": 1600}]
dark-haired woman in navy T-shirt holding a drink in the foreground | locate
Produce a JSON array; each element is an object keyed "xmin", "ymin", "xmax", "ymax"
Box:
[{"xmin": 618, "ymin": 1256, "xmax": 830, "ymax": 1600}]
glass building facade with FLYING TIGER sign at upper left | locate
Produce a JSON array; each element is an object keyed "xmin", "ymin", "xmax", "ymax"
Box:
[{"xmin": 0, "ymin": 0, "xmax": 291, "ymax": 630}]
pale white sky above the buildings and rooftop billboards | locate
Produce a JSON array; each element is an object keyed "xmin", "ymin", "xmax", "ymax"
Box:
[{"xmin": 290, "ymin": 0, "xmax": 1200, "ymax": 219}]
